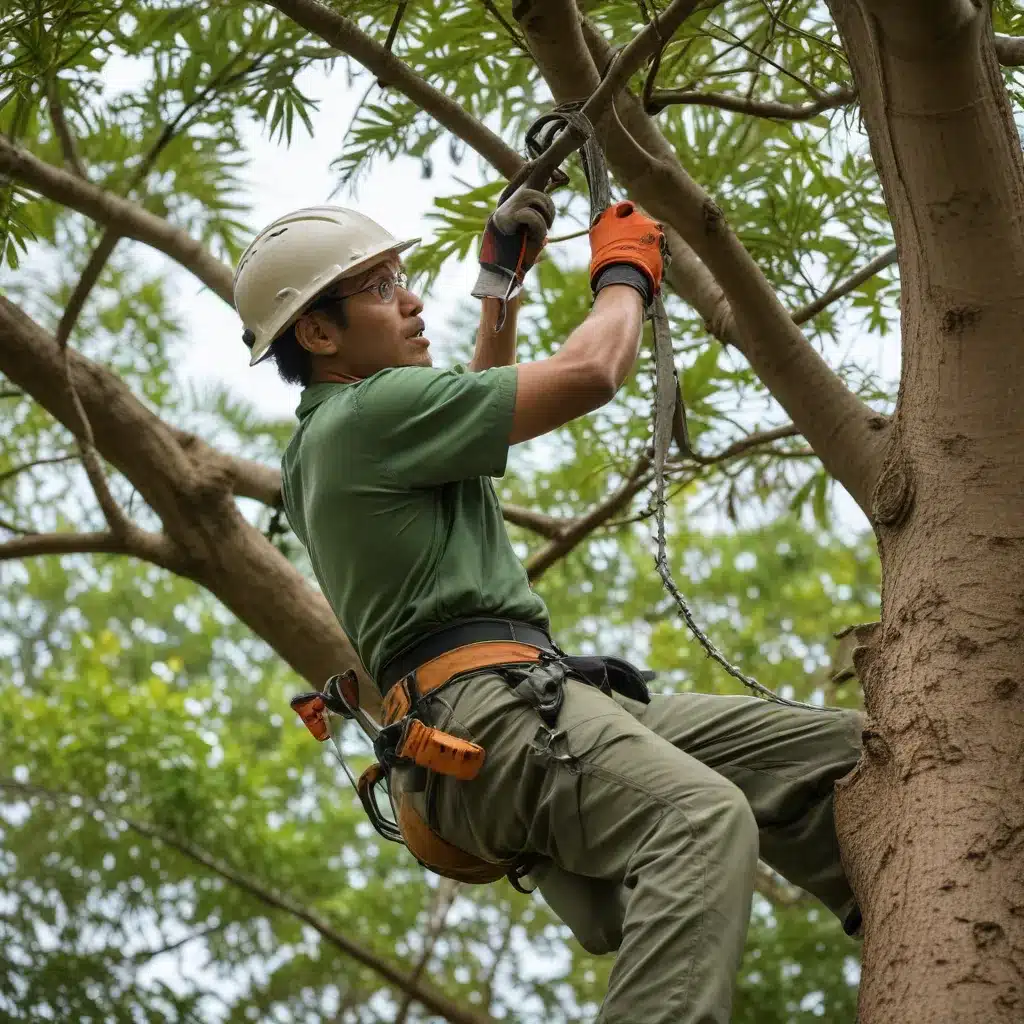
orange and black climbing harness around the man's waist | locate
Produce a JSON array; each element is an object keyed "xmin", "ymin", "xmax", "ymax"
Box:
[{"xmin": 291, "ymin": 618, "xmax": 653, "ymax": 892}]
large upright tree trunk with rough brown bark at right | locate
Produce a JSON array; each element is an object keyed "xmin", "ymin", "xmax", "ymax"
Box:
[{"xmin": 829, "ymin": 0, "xmax": 1024, "ymax": 1024}]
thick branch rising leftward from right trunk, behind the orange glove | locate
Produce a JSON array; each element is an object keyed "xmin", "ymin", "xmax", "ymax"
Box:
[{"xmin": 573, "ymin": 16, "xmax": 884, "ymax": 511}]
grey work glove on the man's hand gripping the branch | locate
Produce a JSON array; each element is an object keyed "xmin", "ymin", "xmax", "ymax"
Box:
[{"xmin": 472, "ymin": 188, "xmax": 555, "ymax": 300}]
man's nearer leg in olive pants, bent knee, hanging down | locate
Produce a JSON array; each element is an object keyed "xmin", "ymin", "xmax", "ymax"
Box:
[{"xmin": 421, "ymin": 674, "xmax": 758, "ymax": 1024}]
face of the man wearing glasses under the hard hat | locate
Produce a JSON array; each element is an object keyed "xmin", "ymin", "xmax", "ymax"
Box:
[{"xmin": 300, "ymin": 255, "xmax": 432, "ymax": 377}]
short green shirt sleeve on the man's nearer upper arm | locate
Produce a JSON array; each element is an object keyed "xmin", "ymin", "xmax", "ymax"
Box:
[{"xmin": 357, "ymin": 366, "xmax": 517, "ymax": 486}]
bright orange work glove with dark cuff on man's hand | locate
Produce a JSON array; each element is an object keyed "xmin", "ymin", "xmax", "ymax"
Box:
[{"xmin": 590, "ymin": 201, "xmax": 666, "ymax": 306}]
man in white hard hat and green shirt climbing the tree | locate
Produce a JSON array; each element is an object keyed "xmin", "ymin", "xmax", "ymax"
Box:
[{"xmin": 234, "ymin": 188, "xmax": 861, "ymax": 1024}]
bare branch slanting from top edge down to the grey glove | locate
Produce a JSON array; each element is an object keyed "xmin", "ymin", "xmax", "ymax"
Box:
[{"xmin": 267, "ymin": 0, "xmax": 523, "ymax": 177}]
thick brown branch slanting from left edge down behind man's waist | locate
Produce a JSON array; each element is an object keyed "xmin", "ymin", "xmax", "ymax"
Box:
[{"xmin": 0, "ymin": 297, "xmax": 380, "ymax": 717}]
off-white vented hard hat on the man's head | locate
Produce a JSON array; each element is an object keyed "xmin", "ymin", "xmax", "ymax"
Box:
[{"xmin": 232, "ymin": 206, "xmax": 420, "ymax": 367}]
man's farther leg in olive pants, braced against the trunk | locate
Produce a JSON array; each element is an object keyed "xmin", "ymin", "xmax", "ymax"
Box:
[{"xmin": 623, "ymin": 693, "xmax": 863, "ymax": 922}]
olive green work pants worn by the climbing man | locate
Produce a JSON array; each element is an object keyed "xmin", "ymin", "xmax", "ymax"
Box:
[{"xmin": 392, "ymin": 673, "xmax": 861, "ymax": 1024}]
